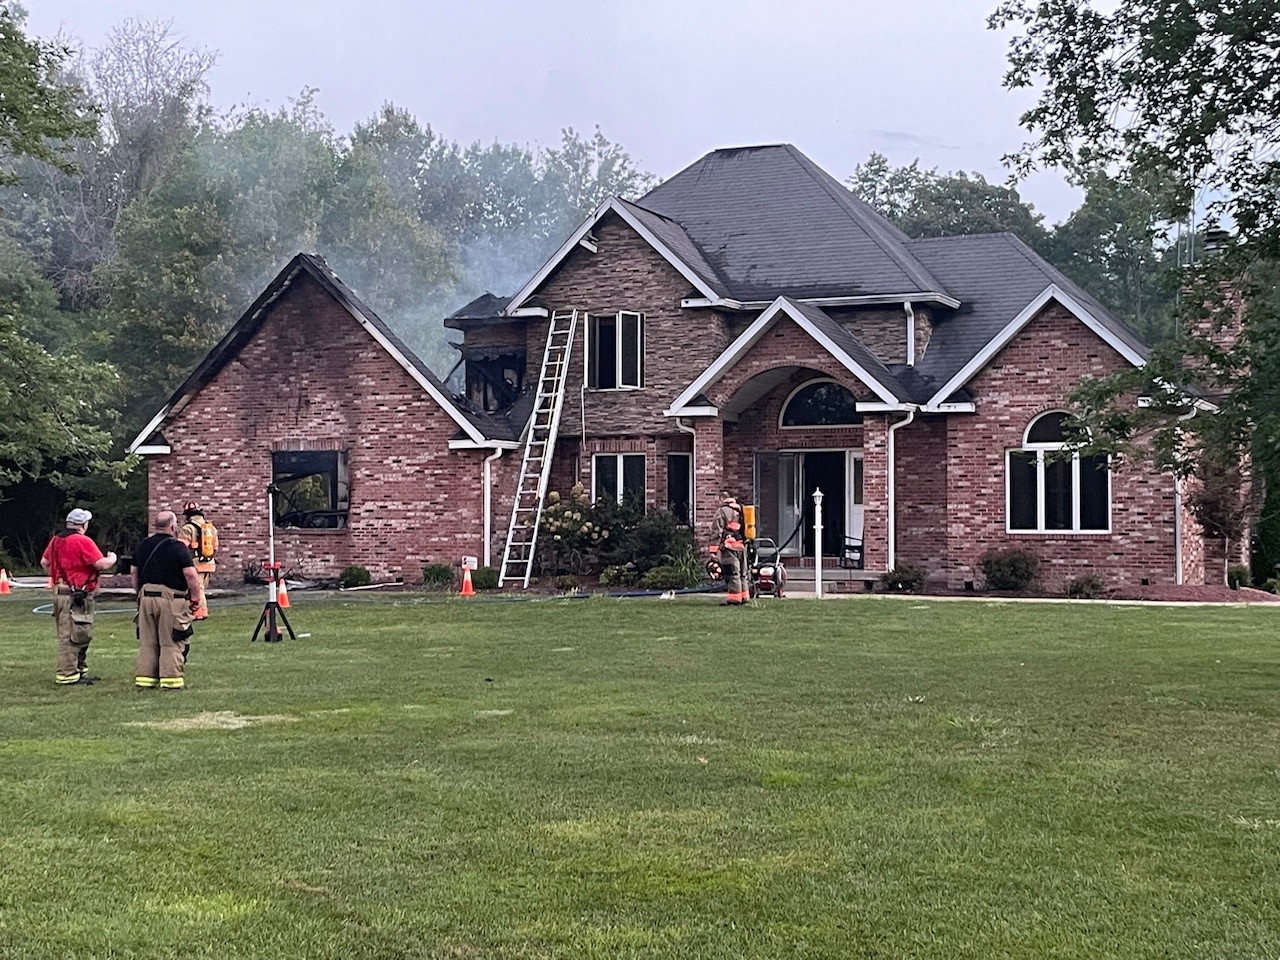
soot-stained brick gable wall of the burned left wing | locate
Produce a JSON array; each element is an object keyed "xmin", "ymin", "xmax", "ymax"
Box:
[{"xmin": 148, "ymin": 274, "xmax": 488, "ymax": 582}]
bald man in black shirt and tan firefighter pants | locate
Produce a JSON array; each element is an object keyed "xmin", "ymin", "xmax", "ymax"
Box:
[{"xmin": 133, "ymin": 509, "xmax": 205, "ymax": 690}]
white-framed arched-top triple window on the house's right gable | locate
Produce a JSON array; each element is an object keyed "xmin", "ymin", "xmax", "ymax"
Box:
[{"xmin": 1005, "ymin": 411, "xmax": 1111, "ymax": 534}]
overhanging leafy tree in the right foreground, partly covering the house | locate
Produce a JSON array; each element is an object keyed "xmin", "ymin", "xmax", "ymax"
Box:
[{"xmin": 989, "ymin": 0, "xmax": 1280, "ymax": 578}]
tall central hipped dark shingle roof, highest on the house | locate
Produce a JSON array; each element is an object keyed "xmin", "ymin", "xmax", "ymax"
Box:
[{"xmin": 637, "ymin": 143, "xmax": 947, "ymax": 301}]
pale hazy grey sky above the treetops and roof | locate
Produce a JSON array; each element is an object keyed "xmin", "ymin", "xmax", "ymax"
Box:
[{"xmin": 27, "ymin": 0, "xmax": 1079, "ymax": 221}]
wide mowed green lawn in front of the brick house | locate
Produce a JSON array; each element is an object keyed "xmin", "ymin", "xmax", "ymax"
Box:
[{"xmin": 0, "ymin": 590, "xmax": 1280, "ymax": 960}]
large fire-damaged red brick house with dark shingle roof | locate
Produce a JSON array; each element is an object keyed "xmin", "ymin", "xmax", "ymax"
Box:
[{"xmin": 131, "ymin": 145, "xmax": 1212, "ymax": 586}]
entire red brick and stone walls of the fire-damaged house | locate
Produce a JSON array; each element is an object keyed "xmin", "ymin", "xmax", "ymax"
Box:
[{"xmin": 150, "ymin": 227, "xmax": 1206, "ymax": 599}]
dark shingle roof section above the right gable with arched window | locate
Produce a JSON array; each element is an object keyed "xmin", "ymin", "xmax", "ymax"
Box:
[{"xmin": 909, "ymin": 233, "xmax": 1148, "ymax": 388}]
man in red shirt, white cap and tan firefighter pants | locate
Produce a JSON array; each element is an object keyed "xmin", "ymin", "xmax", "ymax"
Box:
[{"xmin": 40, "ymin": 507, "xmax": 115, "ymax": 686}]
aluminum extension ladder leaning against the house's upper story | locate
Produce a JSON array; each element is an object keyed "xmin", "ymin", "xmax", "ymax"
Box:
[{"xmin": 498, "ymin": 310, "xmax": 577, "ymax": 588}]
